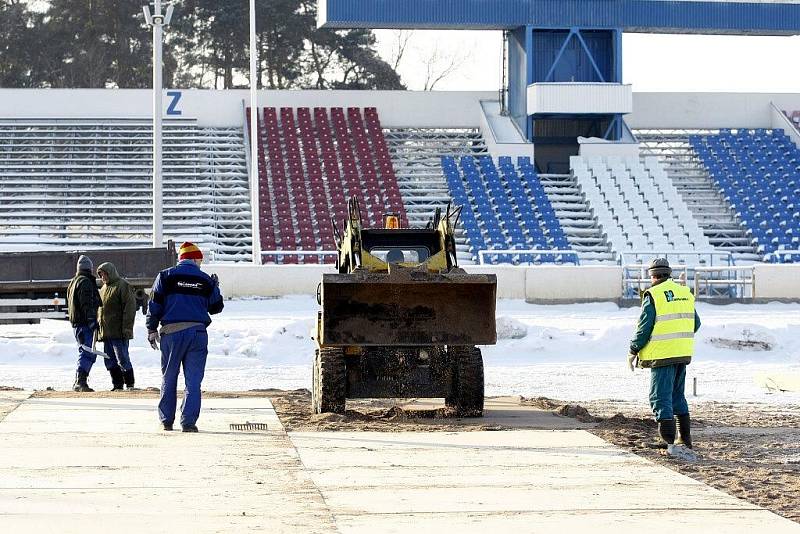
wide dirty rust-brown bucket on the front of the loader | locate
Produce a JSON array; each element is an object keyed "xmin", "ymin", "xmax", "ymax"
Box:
[{"xmin": 320, "ymin": 265, "xmax": 497, "ymax": 346}]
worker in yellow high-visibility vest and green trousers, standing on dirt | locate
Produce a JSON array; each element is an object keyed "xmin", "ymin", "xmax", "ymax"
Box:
[{"xmin": 628, "ymin": 258, "xmax": 700, "ymax": 459}]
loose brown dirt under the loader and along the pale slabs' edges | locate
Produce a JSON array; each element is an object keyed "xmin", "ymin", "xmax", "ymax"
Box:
[{"xmin": 25, "ymin": 388, "xmax": 800, "ymax": 522}]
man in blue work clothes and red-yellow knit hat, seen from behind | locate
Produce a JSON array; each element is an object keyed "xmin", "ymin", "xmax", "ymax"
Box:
[{"xmin": 147, "ymin": 242, "xmax": 224, "ymax": 432}]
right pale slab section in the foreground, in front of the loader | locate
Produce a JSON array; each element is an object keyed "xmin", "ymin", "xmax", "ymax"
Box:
[{"xmin": 290, "ymin": 430, "xmax": 800, "ymax": 534}]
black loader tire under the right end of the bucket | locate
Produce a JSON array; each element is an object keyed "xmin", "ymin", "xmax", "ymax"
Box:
[{"xmin": 445, "ymin": 345, "xmax": 483, "ymax": 417}]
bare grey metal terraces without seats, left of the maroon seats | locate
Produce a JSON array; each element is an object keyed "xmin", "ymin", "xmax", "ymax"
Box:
[{"xmin": 0, "ymin": 119, "xmax": 251, "ymax": 261}]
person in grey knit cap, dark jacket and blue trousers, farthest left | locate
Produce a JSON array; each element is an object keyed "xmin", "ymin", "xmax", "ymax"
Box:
[{"xmin": 67, "ymin": 255, "xmax": 100, "ymax": 392}]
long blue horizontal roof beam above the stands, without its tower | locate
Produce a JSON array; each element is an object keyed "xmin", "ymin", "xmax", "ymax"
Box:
[{"xmin": 318, "ymin": 0, "xmax": 800, "ymax": 35}]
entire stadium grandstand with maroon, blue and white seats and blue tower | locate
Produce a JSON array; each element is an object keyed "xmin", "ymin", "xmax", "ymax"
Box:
[{"xmin": 0, "ymin": 0, "xmax": 800, "ymax": 280}]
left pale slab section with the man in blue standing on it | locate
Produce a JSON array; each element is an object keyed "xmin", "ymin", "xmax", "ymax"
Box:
[{"xmin": 0, "ymin": 398, "xmax": 335, "ymax": 534}]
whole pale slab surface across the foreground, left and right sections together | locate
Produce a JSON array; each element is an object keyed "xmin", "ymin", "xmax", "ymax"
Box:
[{"xmin": 6, "ymin": 392, "xmax": 800, "ymax": 534}]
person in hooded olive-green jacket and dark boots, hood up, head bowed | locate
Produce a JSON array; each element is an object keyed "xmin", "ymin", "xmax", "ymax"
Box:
[{"xmin": 97, "ymin": 262, "xmax": 136, "ymax": 391}]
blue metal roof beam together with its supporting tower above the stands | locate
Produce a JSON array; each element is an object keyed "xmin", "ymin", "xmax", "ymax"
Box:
[{"xmin": 318, "ymin": 0, "xmax": 800, "ymax": 172}]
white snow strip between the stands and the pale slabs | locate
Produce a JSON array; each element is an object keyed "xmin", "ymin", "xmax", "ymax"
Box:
[{"xmin": 0, "ymin": 297, "xmax": 800, "ymax": 404}]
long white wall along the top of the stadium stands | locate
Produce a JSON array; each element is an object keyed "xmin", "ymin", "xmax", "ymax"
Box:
[{"xmin": 6, "ymin": 89, "xmax": 800, "ymax": 128}]
